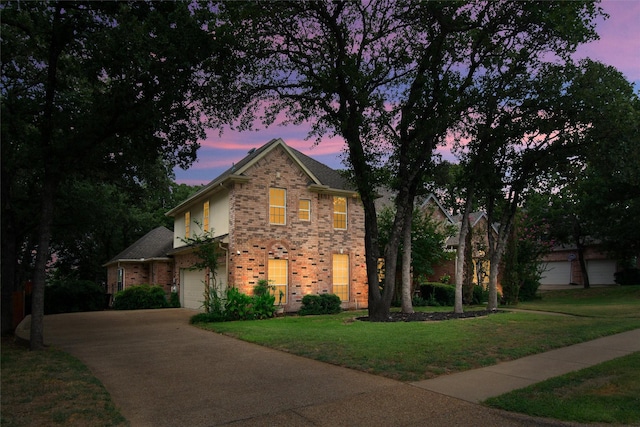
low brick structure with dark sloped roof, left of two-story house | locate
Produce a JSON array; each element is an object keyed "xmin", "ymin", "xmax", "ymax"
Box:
[{"xmin": 104, "ymin": 227, "xmax": 173, "ymax": 295}]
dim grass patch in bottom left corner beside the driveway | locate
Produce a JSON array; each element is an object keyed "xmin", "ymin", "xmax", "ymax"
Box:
[{"xmin": 0, "ymin": 339, "xmax": 129, "ymax": 427}]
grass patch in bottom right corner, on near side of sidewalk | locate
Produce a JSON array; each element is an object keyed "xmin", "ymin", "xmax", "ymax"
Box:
[{"xmin": 485, "ymin": 353, "xmax": 640, "ymax": 425}]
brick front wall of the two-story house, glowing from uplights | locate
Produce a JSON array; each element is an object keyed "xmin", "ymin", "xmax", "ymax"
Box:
[{"xmin": 228, "ymin": 147, "xmax": 367, "ymax": 311}]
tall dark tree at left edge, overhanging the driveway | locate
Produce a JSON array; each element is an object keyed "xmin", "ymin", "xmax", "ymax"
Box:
[{"xmin": 1, "ymin": 1, "xmax": 235, "ymax": 349}]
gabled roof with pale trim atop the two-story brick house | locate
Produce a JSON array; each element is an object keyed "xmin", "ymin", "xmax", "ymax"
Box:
[{"xmin": 167, "ymin": 138, "xmax": 355, "ymax": 216}]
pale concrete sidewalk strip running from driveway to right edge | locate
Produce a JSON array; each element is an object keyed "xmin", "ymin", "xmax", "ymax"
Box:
[{"xmin": 412, "ymin": 329, "xmax": 640, "ymax": 403}]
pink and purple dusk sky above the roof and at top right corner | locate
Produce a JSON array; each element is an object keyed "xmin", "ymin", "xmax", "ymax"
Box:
[{"xmin": 175, "ymin": 0, "xmax": 640, "ymax": 185}]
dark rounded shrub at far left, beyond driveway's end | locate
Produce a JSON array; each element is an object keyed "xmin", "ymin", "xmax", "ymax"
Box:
[{"xmin": 44, "ymin": 280, "xmax": 107, "ymax": 314}]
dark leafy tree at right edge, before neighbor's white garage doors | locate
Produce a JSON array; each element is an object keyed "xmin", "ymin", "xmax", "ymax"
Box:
[{"xmin": 526, "ymin": 63, "xmax": 640, "ymax": 288}]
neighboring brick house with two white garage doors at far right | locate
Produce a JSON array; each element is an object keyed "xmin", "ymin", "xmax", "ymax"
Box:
[{"xmin": 540, "ymin": 245, "xmax": 618, "ymax": 286}]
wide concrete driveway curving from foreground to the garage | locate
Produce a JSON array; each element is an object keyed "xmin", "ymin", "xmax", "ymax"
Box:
[{"xmin": 45, "ymin": 309, "xmax": 570, "ymax": 426}]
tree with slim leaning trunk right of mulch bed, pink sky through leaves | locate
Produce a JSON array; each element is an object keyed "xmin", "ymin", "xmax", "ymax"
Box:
[{"xmin": 456, "ymin": 60, "xmax": 632, "ymax": 309}]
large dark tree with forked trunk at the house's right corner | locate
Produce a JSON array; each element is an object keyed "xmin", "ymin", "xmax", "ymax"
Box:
[{"xmin": 225, "ymin": 0, "xmax": 599, "ymax": 321}]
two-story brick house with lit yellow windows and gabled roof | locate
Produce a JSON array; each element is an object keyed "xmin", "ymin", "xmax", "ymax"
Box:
[{"xmin": 110, "ymin": 139, "xmax": 367, "ymax": 311}]
